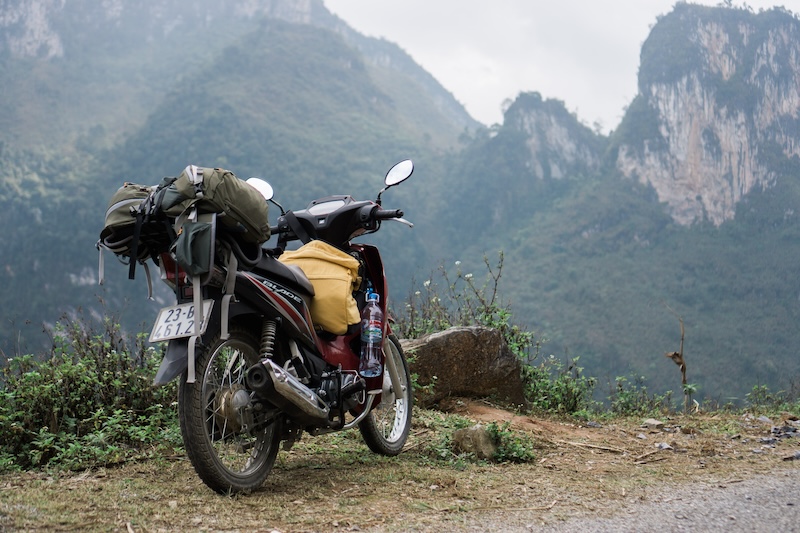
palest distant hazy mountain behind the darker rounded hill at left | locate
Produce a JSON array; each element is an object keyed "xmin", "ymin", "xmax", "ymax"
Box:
[{"xmin": 0, "ymin": 0, "xmax": 480, "ymax": 147}]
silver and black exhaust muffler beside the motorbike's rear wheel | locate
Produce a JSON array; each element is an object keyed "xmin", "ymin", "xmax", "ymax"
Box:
[{"xmin": 245, "ymin": 359, "xmax": 330, "ymax": 422}]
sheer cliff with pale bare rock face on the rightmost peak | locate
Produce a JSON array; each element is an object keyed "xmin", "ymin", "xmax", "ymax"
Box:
[{"xmin": 616, "ymin": 4, "xmax": 800, "ymax": 225}]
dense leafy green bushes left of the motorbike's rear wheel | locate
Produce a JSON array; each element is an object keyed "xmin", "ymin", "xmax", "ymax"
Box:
[{"xmin": 0, "ymin": 312, "xmax": 180, "ymax": 470}]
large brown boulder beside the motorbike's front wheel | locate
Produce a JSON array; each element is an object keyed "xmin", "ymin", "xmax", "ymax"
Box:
[{"xmin": 402, "ymin": 326, "xmax": 527, "ymax": 407}]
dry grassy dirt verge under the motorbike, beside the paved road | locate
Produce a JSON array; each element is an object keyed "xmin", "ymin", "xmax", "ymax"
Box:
[{"xmin": 0, "ymin": 400, "xmax": 800, "ymax": 533}]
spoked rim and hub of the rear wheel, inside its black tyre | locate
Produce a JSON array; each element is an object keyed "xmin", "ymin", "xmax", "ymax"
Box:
[{"xmin": 202, "ymin": 339, "xmax": 274, "ymax": 477}]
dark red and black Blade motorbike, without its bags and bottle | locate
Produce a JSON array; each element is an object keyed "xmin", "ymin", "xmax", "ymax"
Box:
[{"xmin": 150, "ymin": 160, "xmax": 414, "ymax": 494}]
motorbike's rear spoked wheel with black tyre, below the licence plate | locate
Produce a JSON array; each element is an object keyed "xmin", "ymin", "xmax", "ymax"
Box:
[{"xmin": 178, "ymin": 329, "xmax": 280, "ymax": 493}]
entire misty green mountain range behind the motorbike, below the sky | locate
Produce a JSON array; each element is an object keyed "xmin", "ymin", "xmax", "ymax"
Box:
[{"xmin": 0, "ymin": 0, "xmax": 800, "ymax": 403}]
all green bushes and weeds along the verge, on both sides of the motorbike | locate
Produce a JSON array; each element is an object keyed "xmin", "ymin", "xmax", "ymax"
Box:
[{"xmin": 0, "ymin": 253, "xmax": 800, "ymax": 472}]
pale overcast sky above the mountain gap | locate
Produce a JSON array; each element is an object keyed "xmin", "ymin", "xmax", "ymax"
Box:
[{"xmin": 323, "ymin": 0, "xmax": 796, "ymax": 132}]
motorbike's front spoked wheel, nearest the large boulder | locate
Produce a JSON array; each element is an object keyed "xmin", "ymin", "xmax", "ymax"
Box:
[{"xmin": 358, "ymin": 335, "xmax": 413, "ymax": 455}]
